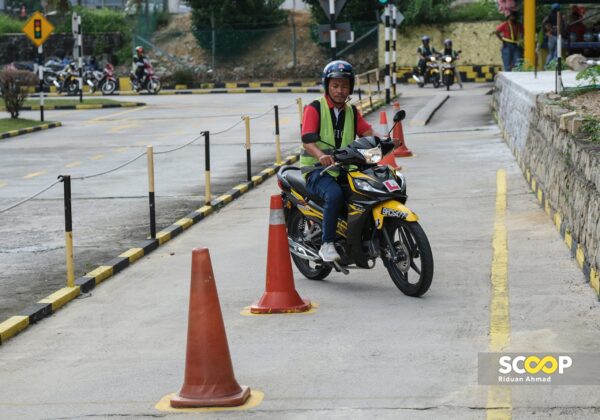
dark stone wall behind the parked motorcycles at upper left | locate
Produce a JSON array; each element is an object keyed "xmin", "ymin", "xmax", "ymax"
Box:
[{"xmin": 0, "ymin": 32, "xmax": 123, "ymax": 64}]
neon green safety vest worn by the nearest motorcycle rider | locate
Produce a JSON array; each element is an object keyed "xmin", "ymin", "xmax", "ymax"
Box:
[{"xmin": 300, "ymin": 96, "xmax": 355, "ymax": 177}]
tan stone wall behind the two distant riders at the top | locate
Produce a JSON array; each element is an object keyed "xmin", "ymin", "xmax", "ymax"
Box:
[{"xmin": 379, "ymin": 21, "xmax": 502, "ymax": 68}]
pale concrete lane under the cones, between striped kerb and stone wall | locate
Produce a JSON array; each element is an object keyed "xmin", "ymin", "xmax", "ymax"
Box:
[{"xmin": 0, "ymin": 83, "xmax": 600, "ymax": 420}]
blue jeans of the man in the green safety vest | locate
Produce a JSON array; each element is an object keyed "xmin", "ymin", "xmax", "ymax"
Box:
[{"xmin": 306, "ymin": 169, "xmax": 344, "ymax": 243}]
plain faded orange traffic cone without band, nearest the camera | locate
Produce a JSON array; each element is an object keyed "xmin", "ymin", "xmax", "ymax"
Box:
[{"xmin": 171, "ymin": 248, "xmax": 250, "ymax": 408}]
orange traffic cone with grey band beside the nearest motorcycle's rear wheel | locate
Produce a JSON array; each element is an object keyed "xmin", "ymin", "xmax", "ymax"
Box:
[{"xmin": 250, "ymin": 195, "xmax": 311, "ymax": 314}]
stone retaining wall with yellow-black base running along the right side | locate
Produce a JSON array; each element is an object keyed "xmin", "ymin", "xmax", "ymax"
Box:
[{"xmin": 493, "ymin": 74, "xmax": 600, "ymax": 293}]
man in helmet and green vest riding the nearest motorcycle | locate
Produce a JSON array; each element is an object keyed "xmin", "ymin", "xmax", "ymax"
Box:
[{"xmin": 300, "ymin": 60, "xmax": 398, "ymax": 262}]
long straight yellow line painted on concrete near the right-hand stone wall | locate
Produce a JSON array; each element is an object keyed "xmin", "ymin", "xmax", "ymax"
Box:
[{"xmin": 487, "ymin": 169, "xmax": 512, "ymax": 419}]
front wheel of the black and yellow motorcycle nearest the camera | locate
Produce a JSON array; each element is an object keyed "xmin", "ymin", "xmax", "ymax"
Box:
[{"xmin": 382, "ymin": 219, "xmax": 433, "ymax": 297}]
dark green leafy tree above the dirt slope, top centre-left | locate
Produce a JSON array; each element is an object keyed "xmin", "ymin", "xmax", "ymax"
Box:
[{"xmin": 187, "ymin": 0, "xmax": 287, "ymax": 54}]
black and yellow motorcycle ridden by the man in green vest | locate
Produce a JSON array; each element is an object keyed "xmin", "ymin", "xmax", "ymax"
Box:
[{"xmin": 277, "ymin": 111, "xmax": 433, "ymax": 297}]
